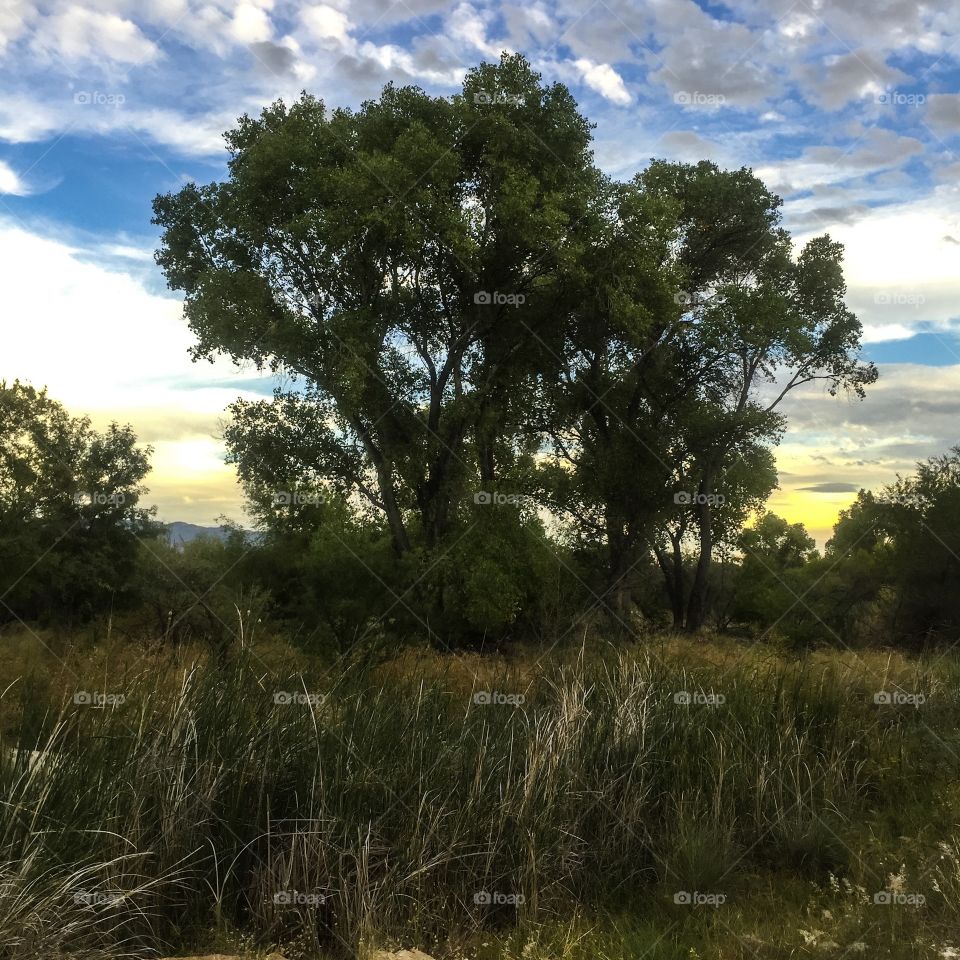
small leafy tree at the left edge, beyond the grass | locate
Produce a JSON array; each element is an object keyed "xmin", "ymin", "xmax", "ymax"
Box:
[{"xmin": 0, "ymin": 380, "xmax": 160, "ymax": 621}]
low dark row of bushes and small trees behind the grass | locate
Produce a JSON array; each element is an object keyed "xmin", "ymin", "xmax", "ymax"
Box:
[{"xmin": 0, "ymin": 381, "xmax": 960, "ymax": 650}]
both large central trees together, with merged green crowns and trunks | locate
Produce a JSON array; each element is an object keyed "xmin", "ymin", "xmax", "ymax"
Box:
[{"xmin": 154, "ymin": 62, "xmax": 875, "ymax": 644}]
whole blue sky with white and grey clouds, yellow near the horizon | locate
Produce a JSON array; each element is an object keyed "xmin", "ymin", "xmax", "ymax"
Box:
[{"xmin": 0, "ymin": 0, "xmax": 960, "ymax": 543}]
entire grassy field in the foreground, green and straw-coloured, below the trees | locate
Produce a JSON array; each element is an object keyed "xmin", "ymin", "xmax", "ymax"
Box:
[{"xmin": 0, "ymin": 631, "xmax": 960, "ymax": 960}]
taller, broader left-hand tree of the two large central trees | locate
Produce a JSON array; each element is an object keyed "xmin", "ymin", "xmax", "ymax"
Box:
[{"xmin": 154, "ymin": 55, "xmax": 598, "ymax": 553}]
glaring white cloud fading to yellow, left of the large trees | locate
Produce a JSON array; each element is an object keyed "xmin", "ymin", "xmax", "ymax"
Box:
[{"xmin": 0, "ymin": 221, "xmax": 272, "ymax": 523}]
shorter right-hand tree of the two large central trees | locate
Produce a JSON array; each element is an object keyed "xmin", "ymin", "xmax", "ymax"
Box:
[{"xmin": 546, "ymin": 161, "xmax": 876, "ymax": 630}]
